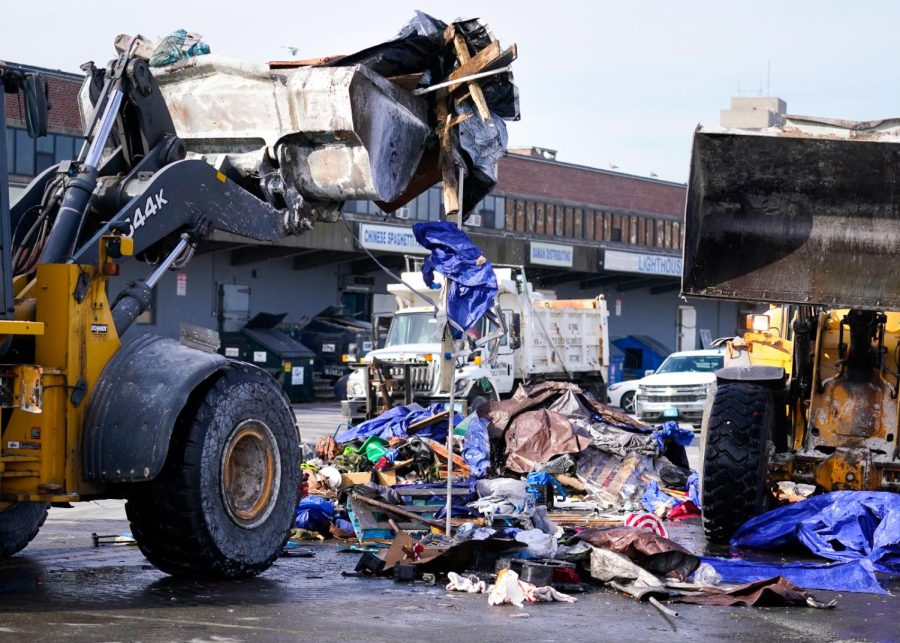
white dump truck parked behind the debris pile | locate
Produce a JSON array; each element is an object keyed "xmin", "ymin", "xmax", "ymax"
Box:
[{"xmin": 342, "ymin": 268, "xmax": 609, "ymax": 421}]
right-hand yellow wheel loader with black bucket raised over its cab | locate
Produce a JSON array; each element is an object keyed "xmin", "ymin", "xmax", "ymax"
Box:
[{"xmin": 682, "ymin": 116, "xmax": 900, "ymax": 542}]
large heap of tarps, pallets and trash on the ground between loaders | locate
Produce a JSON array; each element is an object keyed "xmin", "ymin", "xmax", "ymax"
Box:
[{"xmin": 297, "ymin": 382, "xmax": 833, "ymax": 617}]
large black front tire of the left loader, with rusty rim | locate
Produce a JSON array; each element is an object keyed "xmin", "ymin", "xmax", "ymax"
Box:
[{"xmin": 125, "ymin": 364, "xmax": 300, "ymax": 578}]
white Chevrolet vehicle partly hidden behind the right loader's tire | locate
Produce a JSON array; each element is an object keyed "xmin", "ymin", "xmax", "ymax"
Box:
[{"xmin": 634, "ymin": 347, "xmax": 725, "ymax": 429}]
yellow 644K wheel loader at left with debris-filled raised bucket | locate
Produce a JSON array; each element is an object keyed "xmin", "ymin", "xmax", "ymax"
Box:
[{"xmin": 0, "ymin": 14, "xmax": 517, "ymax": 578}]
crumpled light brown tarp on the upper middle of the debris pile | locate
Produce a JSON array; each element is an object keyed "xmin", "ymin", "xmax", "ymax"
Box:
[{"xmin": 506, "ymin": 409, "xmax": 591, "ymax": 473}]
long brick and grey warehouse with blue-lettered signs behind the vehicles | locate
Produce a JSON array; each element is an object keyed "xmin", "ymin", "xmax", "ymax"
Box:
[{"xmin": 6, "ymin": 61, "xmax": 741, "ymax": 378}]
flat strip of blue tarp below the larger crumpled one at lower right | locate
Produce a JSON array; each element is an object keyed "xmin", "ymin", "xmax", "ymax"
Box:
[{"xmin": 700, "ymin": 556, "xmax": 888, "ymax": 594}]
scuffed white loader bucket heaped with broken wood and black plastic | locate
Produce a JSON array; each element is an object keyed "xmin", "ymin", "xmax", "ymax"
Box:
[{"xmin": 126, "ymin": 12, "xmax": 519, "ymax": 234}]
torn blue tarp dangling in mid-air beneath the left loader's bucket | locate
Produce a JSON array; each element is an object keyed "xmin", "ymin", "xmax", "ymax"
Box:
[{"xmin": 413, "ymin": 221, "xmax": 497, "ymax": 339}]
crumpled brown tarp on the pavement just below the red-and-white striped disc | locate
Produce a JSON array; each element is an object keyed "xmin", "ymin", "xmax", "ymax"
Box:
[{"xmin": 570, "ymin": 527, "xmax": 700, "ymax": 580}]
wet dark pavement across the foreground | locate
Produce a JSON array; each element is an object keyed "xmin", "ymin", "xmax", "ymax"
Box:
[{"xmin": 0, "ymin": 501, "xmax": 900, "ymax": 642}]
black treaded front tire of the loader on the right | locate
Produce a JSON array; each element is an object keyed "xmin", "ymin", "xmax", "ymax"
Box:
[{"xmin": 701, "ymin": 383, "xmax": 774, "ymax": 543}]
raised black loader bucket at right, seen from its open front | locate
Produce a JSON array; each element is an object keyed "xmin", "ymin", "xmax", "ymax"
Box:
[{"xmin": 682, "ymin": 117, "xmax": 900, "ymax": 309}]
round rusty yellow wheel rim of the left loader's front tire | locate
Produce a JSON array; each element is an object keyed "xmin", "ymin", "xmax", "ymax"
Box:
[{"xmin": 221, "ymin": 420, "xmax": 281, "ymax": 529}]
